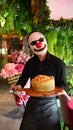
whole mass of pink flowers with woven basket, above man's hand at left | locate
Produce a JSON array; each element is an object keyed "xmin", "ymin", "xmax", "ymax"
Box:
[{"xmin": 0, "ymin": 50, "xmax": 30, "ymax": 86}]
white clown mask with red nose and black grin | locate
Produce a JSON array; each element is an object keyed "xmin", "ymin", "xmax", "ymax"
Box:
[{"xmin": 28, "ymin": 32, "xmax": 47, "ymax": 55}]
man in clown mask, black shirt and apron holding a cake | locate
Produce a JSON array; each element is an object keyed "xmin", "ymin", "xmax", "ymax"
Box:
[{"xmin": 11, "ymin": 31, "xmax": 66, "ymax": 130}]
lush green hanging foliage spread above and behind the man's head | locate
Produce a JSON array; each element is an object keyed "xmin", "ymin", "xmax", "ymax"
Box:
[{"xmin": 0, "ymin": 0, "xmax": 73, "ymax": 66}]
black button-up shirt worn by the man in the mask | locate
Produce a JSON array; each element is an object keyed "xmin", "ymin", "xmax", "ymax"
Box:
[{"xmin": 17, "ymin": 52, "xmax": 66, "ymax": 89}]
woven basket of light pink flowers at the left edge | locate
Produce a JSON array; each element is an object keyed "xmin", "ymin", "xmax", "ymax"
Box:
[{"xmin": 0, "ymin": 63, "xmax": 24, "ymax": 86}]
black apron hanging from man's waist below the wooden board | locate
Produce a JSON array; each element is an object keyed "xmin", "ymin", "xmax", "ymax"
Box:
[{"xmin": 20, "ymin": 97, "xmax": 61, "ymax": 130}]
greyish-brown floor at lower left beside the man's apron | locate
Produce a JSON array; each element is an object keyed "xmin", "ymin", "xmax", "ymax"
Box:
[{"xmin": 0, "ymin": 80, "xmax": 22, "ymax": 130}]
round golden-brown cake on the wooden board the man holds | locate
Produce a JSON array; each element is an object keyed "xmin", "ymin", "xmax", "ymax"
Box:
[{"xmin": 31, "ymin": 75, "xmax": 55, "ymax": 92}]
